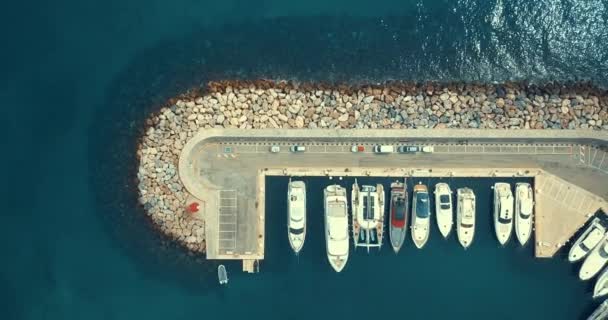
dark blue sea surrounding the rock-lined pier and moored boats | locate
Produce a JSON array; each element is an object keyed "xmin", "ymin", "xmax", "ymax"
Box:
[{"xmin": 0, "ymin": 0, "xmax": 608, "ymax": 319}]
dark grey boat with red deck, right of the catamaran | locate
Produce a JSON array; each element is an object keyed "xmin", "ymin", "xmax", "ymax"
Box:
[{"xmin": 389, "ymin": 179, "xmax": 408, "ymax": 253}]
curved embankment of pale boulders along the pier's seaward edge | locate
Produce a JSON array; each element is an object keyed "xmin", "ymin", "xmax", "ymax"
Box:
[{"xmin": 138, "ymin": 81, "xmax": 608, "ymax": 252}]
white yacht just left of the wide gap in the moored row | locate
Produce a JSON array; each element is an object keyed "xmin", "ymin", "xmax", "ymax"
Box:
[{"xmin": 456, "ymin": 188, "xmax": 475, "ymax": 249}]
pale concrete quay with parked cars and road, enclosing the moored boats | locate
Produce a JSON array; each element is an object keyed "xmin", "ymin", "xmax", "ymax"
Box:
[{"xmin": 173, "ymin": 129, "xmax": 608, "ymax": 272}]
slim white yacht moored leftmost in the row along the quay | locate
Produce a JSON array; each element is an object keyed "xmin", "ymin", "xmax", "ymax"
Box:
[{"xmin": 287, "ymin": 181, "xmax": 306, "ymax": 254}]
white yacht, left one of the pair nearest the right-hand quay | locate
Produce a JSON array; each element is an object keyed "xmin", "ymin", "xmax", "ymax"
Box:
[{"xmin": 494, "ymin": 182, "xmax": 513, "ymax": 246}]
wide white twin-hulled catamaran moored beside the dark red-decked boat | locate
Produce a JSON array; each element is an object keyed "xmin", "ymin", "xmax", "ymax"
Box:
[{"xmin": 351, "ymin": 179, "xmax": 385, "ymax": 252}]
